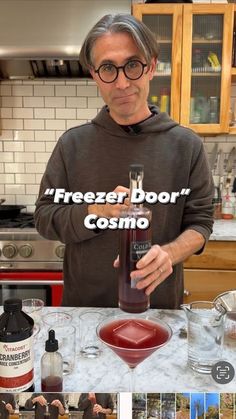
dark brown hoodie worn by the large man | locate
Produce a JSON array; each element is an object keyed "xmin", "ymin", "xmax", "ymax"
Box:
[{"xmin": 35, "ymin": 107, "xmax": 213, "ymax": 308}]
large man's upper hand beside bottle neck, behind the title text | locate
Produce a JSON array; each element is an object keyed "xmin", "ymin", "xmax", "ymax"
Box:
[{"xmin": 88, "ymin": 186, "xmax": 129, "ymax": 218}]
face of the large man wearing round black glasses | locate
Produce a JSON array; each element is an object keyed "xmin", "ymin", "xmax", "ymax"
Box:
[{"xmin": 91, "ymin": 33, "xmax": 156, "ymax": 125}]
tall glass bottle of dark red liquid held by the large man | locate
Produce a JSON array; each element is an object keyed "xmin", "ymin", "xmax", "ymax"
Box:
[{"xmin": 119, "ymin": 164, "xmax": 151, "ymax": 313}]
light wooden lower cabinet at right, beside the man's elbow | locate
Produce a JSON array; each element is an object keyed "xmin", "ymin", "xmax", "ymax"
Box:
[{"xmin": 184, "ymin": 240, "xmax": 236, "ymax": 303}]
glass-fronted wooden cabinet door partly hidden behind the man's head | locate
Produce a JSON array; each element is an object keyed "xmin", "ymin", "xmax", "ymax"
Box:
[{"xmin": 132, "ymin": 4, "xmax": 183, "ymax": 121}]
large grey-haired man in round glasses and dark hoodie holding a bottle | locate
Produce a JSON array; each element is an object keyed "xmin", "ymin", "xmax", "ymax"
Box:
[{"xmin": 35, "ymin": 15, "xmax": 213, "ymax": 308}]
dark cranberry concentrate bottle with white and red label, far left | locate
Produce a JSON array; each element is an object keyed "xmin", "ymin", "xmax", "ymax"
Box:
[{"xmin": 0, "ymin": 298, "xmax": 34, "ymax": 392}]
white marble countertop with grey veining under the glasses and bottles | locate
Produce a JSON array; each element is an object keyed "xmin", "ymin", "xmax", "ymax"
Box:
[{"xmin": 31, "ymin": 307, "xmax": 236, "ymax": 392}]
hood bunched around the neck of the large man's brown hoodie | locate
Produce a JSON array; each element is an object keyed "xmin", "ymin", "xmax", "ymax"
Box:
[{"xmin": 92, "ymin": 105, "xmax": 179, "ymax": 137}]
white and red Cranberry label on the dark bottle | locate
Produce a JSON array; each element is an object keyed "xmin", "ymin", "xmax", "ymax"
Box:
[{"xmin": 0, "ymin": 336, "xmax": 34, "ymax": 392}]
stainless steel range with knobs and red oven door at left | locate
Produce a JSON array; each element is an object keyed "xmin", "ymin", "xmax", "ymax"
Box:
[{"xmin": 0, "ymin": 214, "xmax": 65, "ymax": 305}]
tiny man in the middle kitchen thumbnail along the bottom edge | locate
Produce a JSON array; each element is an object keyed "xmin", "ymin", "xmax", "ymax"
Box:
[{"xmin": 25, "ymin": 393, "xmax": 65, "ymax": 419}]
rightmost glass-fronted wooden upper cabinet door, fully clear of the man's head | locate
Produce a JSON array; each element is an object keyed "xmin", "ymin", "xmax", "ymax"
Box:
[{"xmin": 180, "ymin": 4, "xmax": 233, "ymax": 133}]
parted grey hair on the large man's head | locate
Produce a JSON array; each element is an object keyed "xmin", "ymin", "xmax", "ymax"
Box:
[{"xmin": 79, "ymin": 13, "xmax": 159, "ymax": 70}]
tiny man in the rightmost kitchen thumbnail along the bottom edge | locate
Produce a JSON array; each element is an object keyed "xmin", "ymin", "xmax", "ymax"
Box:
[{"xmin": 78, "ymin": 393, "xmax": 114, "ymax": 419}]
